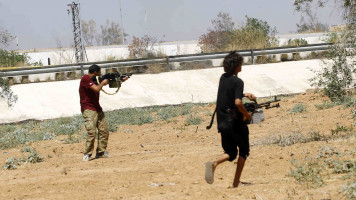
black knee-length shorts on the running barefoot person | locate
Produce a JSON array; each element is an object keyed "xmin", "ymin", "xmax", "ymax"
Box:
[{"xmin": 221, "ymin": 124, "xmax": 250, "ymax": 162}]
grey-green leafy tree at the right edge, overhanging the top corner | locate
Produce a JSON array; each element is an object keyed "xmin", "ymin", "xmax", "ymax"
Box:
[{"xmin": 294, "ymin": 0, "xmax": 356, "ymax": 102}]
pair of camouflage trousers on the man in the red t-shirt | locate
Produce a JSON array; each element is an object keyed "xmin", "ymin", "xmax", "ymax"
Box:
[{"xmin": 82, "ymin": 109, "xmax": 109, "ymax": 155}]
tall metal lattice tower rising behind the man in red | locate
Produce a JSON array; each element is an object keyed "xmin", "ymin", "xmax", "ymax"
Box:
[{"xmin": 68, "ymin": 2, "xmax": 85, "ymax": 71}]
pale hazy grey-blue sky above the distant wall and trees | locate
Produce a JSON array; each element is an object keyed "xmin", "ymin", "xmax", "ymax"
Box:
[{"xmin": 0, "ymin": 0, "xmax": 343, "ymax": 50}]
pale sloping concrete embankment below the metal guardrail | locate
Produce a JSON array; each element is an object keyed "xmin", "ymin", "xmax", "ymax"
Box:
[{"xmin": 0, "ymin": 60, "xmax": 323, "ymax": 123}]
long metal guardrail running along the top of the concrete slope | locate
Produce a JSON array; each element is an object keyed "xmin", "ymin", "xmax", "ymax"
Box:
[{"xmin": 0, "ymin": 43, "xmax": 332, "ymax": 77}]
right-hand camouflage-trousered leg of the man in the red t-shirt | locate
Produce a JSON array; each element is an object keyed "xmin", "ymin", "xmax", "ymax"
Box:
[{"xmin": 96, "ymin": 112, "xmax": 109, "ymax": 156}]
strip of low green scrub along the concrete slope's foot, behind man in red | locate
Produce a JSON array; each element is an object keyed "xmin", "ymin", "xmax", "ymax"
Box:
[{"xmin": 0, "ymin": 104, "xmax": 202, "ymax": 149}]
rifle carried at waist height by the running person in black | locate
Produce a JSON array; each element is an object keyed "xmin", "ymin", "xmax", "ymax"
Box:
[{"xmin": 206, "ymin": 96, "xmax": 280, "ymax": 129}]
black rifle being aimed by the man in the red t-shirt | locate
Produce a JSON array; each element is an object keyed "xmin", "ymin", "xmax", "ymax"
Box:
[{"xmin": 91, "ymin": 72, "xmax": 133, "ymax": 95}]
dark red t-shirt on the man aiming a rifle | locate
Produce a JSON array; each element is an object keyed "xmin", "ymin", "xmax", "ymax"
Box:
[{"xmin": 79, "ymin": 75, "xmax": 103, "ymax": 112}]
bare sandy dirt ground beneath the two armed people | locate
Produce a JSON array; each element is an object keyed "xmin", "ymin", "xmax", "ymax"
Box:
[{"xmin": 0, "ymin": 92, "xmax": 356, "ymax": 199}]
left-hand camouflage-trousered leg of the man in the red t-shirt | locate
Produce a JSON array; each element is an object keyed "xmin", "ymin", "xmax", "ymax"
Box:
[{"xmin": 83, "ymin": 109, "xmax": 98, "ymax": 157}]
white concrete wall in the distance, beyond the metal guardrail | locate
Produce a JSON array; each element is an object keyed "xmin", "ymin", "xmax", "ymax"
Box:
[{"xmin": 24, "ymin": 33, "xmax": 326, "ymax": 65}]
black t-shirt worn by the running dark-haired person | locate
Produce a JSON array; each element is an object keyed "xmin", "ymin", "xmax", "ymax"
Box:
[{"xmin": 216, "ymin": 73, "xmax": 244, "ymax": 132}]
